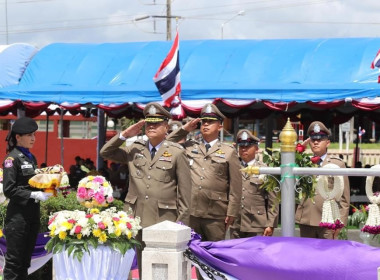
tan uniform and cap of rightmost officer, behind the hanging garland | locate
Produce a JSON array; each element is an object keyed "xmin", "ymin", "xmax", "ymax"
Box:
[{"xmin": 295, "ymin": 122, "xmax": 350, "ymax": 239}]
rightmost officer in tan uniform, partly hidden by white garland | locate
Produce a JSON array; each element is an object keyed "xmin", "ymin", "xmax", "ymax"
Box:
[{"xmin": 296, "ymin": 121, "xmax": 350, "ymax": 239}]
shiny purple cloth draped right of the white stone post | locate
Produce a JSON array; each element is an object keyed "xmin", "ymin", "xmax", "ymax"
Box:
[{"xmin": 189, "ymin": 236, "xmax": 380, "ymax": 280}]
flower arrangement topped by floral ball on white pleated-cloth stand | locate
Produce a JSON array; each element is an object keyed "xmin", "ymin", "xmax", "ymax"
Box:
[{"xmin": 45, "ymin": 176, "xmax": 141, "ymax": 280}]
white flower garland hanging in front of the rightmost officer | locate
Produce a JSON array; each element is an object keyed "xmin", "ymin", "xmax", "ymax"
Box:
[{"xmin": 316, "ymin": 163, "xmax": 344, "ymax": 230}]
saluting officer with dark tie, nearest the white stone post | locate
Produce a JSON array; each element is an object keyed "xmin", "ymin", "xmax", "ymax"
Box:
[{"xmin": 100, "ymin": 103, "xmax": 191, "ymax": 274}]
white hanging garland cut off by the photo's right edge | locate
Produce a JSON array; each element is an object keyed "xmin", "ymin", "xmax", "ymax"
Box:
[{"xmin": 361, "ymin": 165, "xmax": 380, "ymax": 234}]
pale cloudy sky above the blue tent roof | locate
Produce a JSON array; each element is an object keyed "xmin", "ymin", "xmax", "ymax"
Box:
[{"xmin": 0, "ymin": 0, "xmax": 380, "ymax": 48}]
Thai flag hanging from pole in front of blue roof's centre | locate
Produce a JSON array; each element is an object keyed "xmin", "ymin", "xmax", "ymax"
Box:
[{"xmin": 153, "ymin": 31, "xmax": 181, "ymax": 107}]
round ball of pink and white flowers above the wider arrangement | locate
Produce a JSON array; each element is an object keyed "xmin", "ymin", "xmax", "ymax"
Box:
[{"xmin": 77, "ymin": 176, "xmax": 113, "ymax": 208}]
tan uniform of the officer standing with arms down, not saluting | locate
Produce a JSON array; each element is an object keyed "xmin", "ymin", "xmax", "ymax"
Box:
[{"xmin": 231, "ymin": 160, "xmax": 279, "ymax": 238}]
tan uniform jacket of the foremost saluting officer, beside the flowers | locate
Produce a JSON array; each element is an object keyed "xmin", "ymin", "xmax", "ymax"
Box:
[{"xmin": 101, "ymin": 135, "xmax": 191, "ymax": 228}]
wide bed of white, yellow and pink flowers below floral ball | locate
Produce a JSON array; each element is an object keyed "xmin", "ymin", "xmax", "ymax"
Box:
[{"xmin": 46, "ymin": 207, "xmax": 141, "ymax": 260}]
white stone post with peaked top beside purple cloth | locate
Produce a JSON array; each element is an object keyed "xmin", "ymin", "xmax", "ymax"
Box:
[{"xmin": 142, "ymin": 221, "xmax": 191, "ymax": 280}]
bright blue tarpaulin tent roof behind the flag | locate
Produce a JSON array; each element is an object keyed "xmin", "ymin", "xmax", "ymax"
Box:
[{"xmin": 0, "ymin": 38, "xmax": 380, "ymax": 105}]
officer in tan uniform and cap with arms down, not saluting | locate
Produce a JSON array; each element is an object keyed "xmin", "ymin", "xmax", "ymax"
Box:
[{"xmin": 231, "ymin": 129, "xmax": 278, "ymax": 238}]
